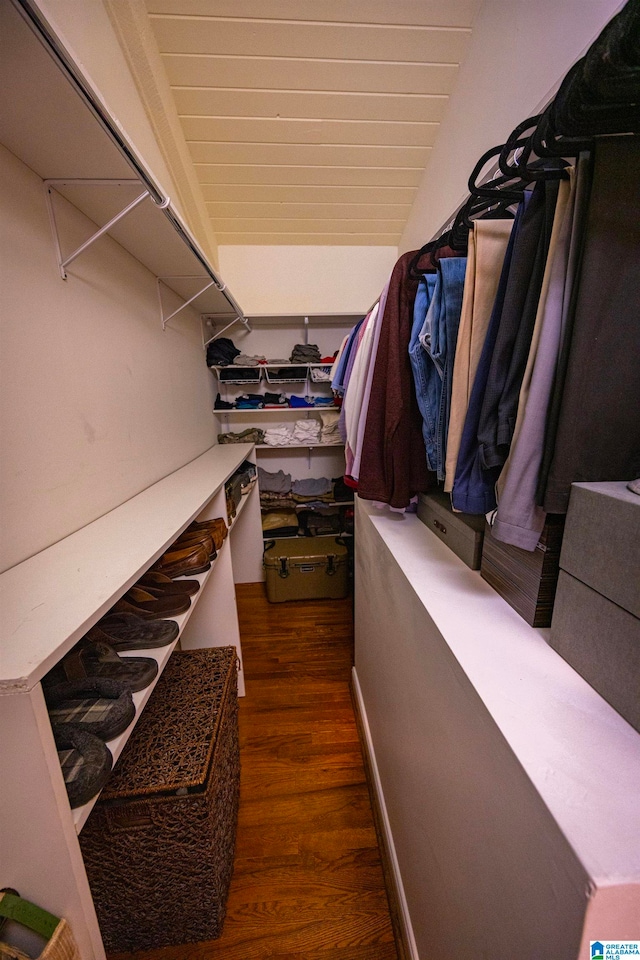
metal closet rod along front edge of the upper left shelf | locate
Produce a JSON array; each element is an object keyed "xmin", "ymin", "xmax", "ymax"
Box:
[{"xmin": 11, "ymin": 0, "xmax": 246, "ymax": 323}]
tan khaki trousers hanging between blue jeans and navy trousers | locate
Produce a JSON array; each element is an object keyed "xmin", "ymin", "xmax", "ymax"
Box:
[{"xmin": 444, "ymin": 220, "xmax": 513, "ymax": 493}]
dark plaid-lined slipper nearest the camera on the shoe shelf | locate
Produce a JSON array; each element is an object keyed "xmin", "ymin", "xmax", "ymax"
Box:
[{"xmin": 51, "ymin": 724, "xmax": 113, "ymax": 808}]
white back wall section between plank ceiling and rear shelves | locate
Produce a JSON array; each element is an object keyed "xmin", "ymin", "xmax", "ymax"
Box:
[{"xmin": 218, "ymin": 245, "xmax": 398, "ymax": 316}]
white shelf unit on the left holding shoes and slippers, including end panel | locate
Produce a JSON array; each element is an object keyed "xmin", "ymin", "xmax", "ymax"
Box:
[{"xmin": 0, "ymin": 444, "xmax": 262, "ymax": 960}]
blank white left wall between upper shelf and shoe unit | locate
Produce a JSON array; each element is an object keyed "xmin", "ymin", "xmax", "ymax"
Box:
[{"xmin": 0, "ymin": 147, "xmax": 215, "ymax": 570}]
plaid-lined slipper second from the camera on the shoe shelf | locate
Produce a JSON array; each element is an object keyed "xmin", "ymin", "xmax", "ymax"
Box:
[{"xmin": 43, "ymin": 677, "xmax": 136, "ymax": 740}]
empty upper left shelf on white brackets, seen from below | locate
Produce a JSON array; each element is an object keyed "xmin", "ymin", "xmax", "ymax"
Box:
[{"xmin": 0, "ymin": 3, "xmax": 242, "ymax": 320}]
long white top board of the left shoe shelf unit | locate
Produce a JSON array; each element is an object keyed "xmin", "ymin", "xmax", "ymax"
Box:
[{"xmin": 0, "ymin": 443, "xmax": 254, "ymax": 694}]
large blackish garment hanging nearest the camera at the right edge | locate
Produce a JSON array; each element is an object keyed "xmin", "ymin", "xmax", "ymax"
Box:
[{"xmin": 543, "ymin": 137, "xmax": 640, "ymax": 513}]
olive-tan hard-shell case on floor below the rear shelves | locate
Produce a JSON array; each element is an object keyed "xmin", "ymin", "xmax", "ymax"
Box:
[{"xmin": 263, "ymin": 537, "xmax": 349, "ymax": 603}]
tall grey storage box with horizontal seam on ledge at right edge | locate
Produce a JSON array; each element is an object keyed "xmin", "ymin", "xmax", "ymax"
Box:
[{"xmin": 549, "ymin": 481, "xmax": 640, "ymax": 730}]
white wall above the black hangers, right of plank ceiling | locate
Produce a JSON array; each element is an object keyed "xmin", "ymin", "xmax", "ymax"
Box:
[{"xmin": 399, "ymin": 0, "xmax": 624, "ymax": 253}]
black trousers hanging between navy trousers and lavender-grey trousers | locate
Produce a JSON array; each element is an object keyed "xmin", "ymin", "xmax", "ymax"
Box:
[{"xmin": 478, "ymin": 180, "xmax": 558, "ymax": 470}]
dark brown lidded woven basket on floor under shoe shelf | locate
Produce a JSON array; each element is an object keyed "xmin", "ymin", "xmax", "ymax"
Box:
[{"xmin": 80, "ymin": 647, "xmax": 240, "ymax": 953}]
